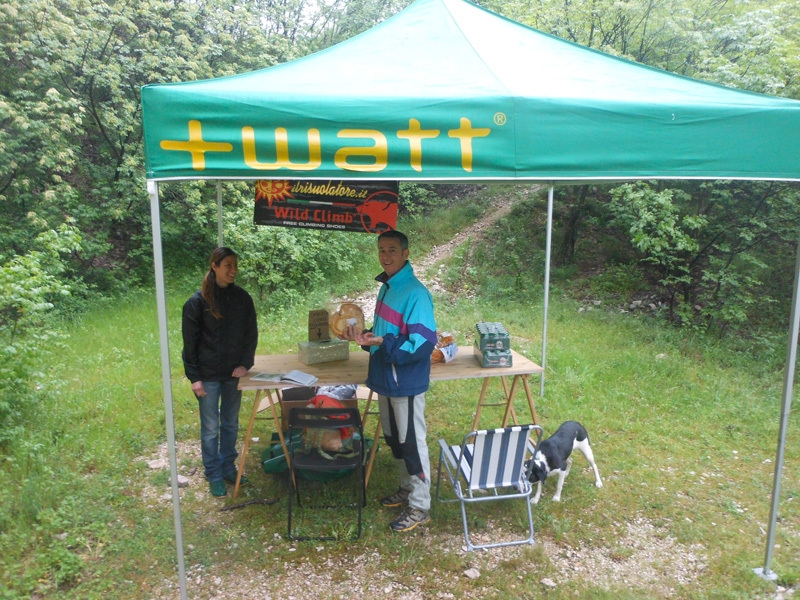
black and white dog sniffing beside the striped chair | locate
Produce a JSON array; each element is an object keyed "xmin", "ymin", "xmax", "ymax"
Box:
[{"xmin": 529, "ymin": 421, "xmax": 603, "ymax": 504}]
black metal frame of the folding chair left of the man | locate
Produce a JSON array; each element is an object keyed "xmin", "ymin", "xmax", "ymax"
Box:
[{"xmin": 288, "ymin": 408, "xmax": 366, "ymax": 540}]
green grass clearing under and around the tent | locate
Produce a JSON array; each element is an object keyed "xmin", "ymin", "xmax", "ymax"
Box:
[{"xmin": 0, "ymin": 195, "xmax": 800, "ymax": 599}]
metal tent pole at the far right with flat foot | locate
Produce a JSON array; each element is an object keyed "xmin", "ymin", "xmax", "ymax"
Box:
[{"xmin": 753, "ymin": 232, "xmax": 800, "ymax": 581}]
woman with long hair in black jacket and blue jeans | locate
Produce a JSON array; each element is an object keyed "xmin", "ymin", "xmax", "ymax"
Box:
[{"xmin": 182, "ymin": 247, "xmax": 258, "ymax": 497}]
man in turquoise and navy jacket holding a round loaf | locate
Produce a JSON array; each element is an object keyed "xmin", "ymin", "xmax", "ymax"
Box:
[{"xmin": 344, "ymin": 230, "xmax": 436, "ymax": 531}]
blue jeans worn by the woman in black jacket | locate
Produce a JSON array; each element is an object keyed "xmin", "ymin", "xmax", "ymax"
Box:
[{"xmin": 197, "ymin": 378, "xmax": 242, "ymax": 481}]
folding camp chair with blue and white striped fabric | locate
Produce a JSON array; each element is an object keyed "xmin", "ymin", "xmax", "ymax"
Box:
[{"xmin": 436, "ymin": 425, "xmax": 542, "ymax": 551}]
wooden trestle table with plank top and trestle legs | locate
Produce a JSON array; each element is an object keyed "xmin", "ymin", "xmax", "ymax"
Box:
[{"xmin": 233, "ymin": 346, "xmax": 543, "ymax": 497}]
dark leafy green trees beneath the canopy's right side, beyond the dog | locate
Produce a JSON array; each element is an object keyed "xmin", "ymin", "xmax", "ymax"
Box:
[{"xmin": 606, "ymin": 181, "xmax": 800, "ymax": 332}]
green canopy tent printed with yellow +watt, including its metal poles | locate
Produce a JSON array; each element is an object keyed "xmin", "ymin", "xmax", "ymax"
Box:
[{"xmin": 142, "ymin": 0, "xmax": 800, "ymax": 593}]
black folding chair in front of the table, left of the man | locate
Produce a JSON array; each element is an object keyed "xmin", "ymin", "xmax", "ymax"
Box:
[{"xmin": 288, "ymin": 408, "xmax": 366, "ymax": 540}]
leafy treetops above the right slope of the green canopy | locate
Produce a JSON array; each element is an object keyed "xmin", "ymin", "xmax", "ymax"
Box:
[{"xmin": 482, "ymin": 0, "xmax": 800, "ymax": 98}]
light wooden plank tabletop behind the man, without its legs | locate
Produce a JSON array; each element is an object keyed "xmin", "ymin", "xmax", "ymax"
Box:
[{"xmin": 239, "ymin": 346, "xmax": 543, "ymax": 390}]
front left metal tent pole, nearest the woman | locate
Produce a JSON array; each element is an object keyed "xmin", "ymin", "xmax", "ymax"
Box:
[{"xmin": 147, "ymin": 180, "xmax": 188, "ymax": 600}]
